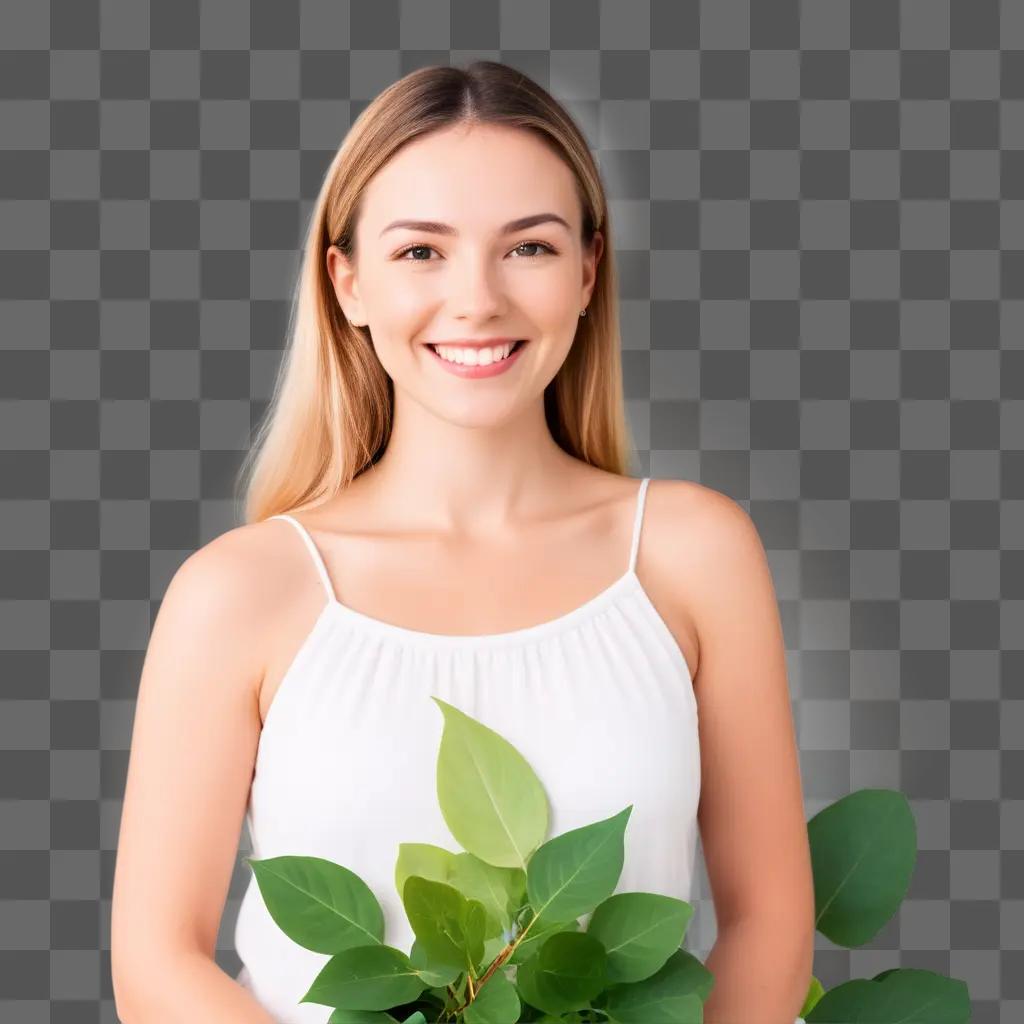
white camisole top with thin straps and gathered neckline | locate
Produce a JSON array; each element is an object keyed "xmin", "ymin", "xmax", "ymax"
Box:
[{"xmin": 234, "ymin": 477, "xmax": 700, "ymax": 1024}]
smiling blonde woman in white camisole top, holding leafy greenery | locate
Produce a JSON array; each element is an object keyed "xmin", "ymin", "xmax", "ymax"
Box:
[{"xmin": 112, "ymin": 61, "xmax": 813, "ymax": 1024}]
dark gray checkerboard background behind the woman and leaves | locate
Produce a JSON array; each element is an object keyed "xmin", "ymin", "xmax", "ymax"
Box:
[{"xmin": 0, "ymin": 0, "xmax": 1024, "ymax": 1024}]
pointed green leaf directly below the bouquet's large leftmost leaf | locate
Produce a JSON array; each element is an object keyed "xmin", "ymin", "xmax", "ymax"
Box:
[{"xmin": 299, "ymin": 945, "xmax": 426, "ymax": 1010}]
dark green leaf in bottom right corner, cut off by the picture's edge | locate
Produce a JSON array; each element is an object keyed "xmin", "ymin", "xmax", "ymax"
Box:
[{"xmin": 805, "ymin": 968, "xmax": 971, "ymax": 1024}]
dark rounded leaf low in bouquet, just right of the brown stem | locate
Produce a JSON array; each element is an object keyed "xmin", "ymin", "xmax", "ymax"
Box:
[{"xmin": 516, "ymin": 932, "xmax": 607, "ymax": 1014}]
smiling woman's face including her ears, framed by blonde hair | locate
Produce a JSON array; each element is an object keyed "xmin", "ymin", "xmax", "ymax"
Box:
[{"xmin": 328, "ymin": 126, "xmax": 603, "ymax": 425}]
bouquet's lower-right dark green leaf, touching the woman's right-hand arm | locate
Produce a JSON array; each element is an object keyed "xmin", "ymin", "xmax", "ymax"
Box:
[{"xmin": 593, "ymin": 949, "xmax": 715, "ymax": 1024}]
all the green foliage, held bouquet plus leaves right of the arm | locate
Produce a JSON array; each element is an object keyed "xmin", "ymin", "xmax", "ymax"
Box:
[{"xmin": 247, "ymin": 697, "xmax": 970, "ymax": 1024}]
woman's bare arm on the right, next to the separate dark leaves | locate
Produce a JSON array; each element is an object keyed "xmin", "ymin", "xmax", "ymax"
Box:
[{"xmin": 694, "ymin": 492, "xmax": 814, "ymax": 1024}]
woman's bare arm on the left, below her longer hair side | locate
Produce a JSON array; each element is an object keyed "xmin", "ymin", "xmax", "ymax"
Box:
[{"xmin": 111, "ymin": 526, "xmax": 274, "ymax": 1024}]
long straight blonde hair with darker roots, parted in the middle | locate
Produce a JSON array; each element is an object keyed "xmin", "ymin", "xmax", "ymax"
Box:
[{"xmin": 239, "ymin": 60, "xmax": 632, "ymax": 523}]
